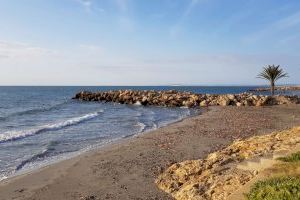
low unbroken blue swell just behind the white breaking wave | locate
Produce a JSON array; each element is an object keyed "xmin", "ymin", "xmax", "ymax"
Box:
[{"xmin": 0, "ymin": 101, "xmax": 70, "ymax": 121}]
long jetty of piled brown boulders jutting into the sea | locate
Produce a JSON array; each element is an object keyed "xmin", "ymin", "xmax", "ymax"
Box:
[{"xmin": 73, "ymin": 90, "xmax": 300, "ymax": 108}]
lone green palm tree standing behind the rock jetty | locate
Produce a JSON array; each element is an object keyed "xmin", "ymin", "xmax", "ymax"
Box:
[{"xmin": 257, "ymin": 65, "xmax": 288, "ymax": 96}]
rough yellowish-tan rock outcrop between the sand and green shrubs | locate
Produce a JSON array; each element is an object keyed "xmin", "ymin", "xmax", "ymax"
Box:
[{"xmin": 156, "ymin": 127, "xmax": 300, "ymax": 200}]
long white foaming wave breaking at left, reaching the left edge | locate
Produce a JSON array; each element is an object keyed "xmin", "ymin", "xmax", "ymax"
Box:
[{"xmin": 0, "ymin": 110, "xmax": 103, "ymax": 143}]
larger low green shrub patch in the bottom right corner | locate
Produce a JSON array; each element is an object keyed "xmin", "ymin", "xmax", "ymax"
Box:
[{"xmin": 246, "ymin": 177, "xmax": 300, "ymax": 200}]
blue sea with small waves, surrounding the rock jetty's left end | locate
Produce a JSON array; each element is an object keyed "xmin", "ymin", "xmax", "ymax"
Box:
[{"xmin": 0, "ymin": 86, "xmax": 298, "ymax": 179}]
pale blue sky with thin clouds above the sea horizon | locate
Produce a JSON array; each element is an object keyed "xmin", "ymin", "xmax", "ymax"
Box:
[{"xmin": 0, "ymin": 0, "xmax": 300, "ymax": 85}]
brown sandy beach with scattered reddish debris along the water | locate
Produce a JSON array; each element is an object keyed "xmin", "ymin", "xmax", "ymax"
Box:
[{"xmin": 0, "ymin": 105, "xmax": 300, "ymax": 200}]
